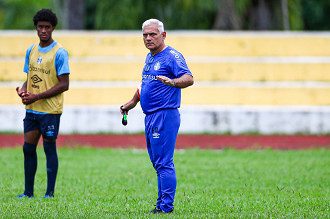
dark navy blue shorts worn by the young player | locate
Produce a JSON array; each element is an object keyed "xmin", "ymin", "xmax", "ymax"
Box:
[{"xmin": 23, "ymin": 112, "xmax": 62, "ymax": 139}]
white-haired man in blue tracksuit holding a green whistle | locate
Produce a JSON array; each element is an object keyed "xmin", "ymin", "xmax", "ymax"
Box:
[{"xmin": 120, "ymin": 19, "xmax": 194, "ymax": 214}]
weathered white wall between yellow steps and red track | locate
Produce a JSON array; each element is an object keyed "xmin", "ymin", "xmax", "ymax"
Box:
[{"xmin": 0, "ymin": 105, "xmax": 330, "ymax": 134}]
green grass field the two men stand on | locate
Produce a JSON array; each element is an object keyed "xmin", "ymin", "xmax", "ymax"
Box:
[{"xmin": 0, "ymin": 147, "xmax": 330, "ymax": 218}]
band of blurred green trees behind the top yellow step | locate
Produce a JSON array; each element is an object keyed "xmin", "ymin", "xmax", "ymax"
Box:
[{"xmin": 0, "ymin": 0, "xmax": 330, "ymax": 30}]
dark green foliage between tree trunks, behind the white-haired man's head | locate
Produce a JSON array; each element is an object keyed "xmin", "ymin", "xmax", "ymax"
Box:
[{"xmin": 86, "ymin": 0, "xmax": 216, "ymax": 30}]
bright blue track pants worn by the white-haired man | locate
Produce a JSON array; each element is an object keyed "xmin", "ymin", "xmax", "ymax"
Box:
[{"xmin": 145, "ymin": 109, "xmax": 180, "ymax": 212}]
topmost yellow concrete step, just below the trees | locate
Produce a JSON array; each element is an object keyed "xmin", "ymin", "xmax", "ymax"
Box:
[{"xmin": 0, "ymin": 30, "xmax": 330, "ymax": 57}]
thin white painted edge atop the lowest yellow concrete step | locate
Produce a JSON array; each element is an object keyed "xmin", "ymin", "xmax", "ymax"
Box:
[{"xmin": 0, "ymin": 81, "xmax": 330, "ymax": 88}]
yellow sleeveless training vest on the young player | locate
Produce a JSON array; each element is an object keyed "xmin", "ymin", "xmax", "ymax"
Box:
[{"xmin": 25, "ymin": 43, "xmax": 63, "ymax": 114}]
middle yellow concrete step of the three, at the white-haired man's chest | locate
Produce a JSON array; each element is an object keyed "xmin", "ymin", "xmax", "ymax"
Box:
[{"xmin": 0, "ymin": 57, "xmax": 330, "ymax": 81}]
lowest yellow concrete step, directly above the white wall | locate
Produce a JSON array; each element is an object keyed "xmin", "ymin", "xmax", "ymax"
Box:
[{"xmin": 0, "ymin": 81, "xmax": 330, "ymax": 106}]
